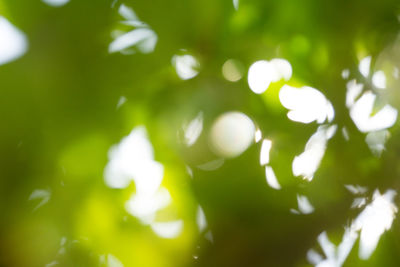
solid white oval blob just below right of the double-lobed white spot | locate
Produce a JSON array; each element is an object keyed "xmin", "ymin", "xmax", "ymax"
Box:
[{"xmin": 279, "ymin": 85, "xmax": 335, "ymax": 123}]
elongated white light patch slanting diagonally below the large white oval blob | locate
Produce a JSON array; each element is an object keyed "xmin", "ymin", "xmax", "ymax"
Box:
[{"xmin": 292, "ymin": 125, "xmax": 337, "ymax": 181}]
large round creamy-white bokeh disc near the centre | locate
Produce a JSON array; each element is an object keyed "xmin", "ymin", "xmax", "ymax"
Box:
[{"xmin": 210, "ymin": 112, "xmax": 255, "ymax": 158}]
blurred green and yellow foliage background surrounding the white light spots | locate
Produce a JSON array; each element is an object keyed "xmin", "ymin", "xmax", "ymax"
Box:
[{"xmin": 0, "ymin": 0, "xmax": 400, "ymax": 267}]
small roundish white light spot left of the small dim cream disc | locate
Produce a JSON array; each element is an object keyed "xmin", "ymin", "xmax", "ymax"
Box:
[{"xmin": 172, "ymin": 55, "xmax": 200, "ymax": 80}]
